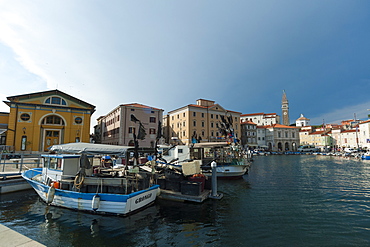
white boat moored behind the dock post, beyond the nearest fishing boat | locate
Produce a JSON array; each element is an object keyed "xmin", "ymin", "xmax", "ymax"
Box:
[{"xmin": 159, "ymin": 142, "xmax": 250, "ymax": 178}]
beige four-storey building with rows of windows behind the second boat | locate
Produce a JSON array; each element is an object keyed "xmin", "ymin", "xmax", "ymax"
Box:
[{"xmin": 163, "ymin": 99, "xmax": 241, "ymax": 145}]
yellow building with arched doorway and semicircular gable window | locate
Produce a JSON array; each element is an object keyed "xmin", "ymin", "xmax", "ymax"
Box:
[{"xmin": 4, "ymin": 90, "xmax": 95, "ymax": 152}]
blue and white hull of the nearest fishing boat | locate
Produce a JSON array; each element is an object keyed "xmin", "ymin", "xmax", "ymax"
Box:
[{"xmin": 22, "ymin": 169, "xmax": 160, "ymax": 215}]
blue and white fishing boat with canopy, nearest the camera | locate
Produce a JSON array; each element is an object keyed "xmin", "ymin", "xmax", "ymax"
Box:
[{"xmin": 22, "ymin": 143, "xmax": 160, "ymax": 215}]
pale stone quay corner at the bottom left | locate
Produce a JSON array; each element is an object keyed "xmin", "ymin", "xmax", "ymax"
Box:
[{"xmin": 0, "ymin": 224, "xmax": 45, "ymax": 247}]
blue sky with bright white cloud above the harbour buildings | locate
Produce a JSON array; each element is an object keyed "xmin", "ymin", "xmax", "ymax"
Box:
[{"xmin": 0, "ymin": 0, "xmax": 370, "ymax": 127}]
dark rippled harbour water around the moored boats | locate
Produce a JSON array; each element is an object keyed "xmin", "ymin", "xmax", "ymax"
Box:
[{"xmin": 0, "ymin": 155, "xmax": 370, "ymax": 246}]
